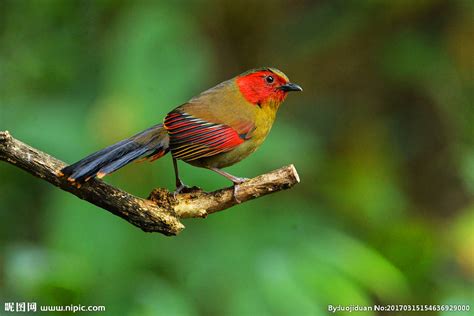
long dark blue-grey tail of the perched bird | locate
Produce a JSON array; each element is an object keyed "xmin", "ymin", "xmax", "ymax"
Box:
[{"xmin": 59, "ymin": 124, "xmax": 169, "ymax": 184}]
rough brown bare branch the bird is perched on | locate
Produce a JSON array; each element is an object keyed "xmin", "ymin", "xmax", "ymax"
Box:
[{"xmin": 0, "ymin": 131, "xmax": 299, "ymax": 236}]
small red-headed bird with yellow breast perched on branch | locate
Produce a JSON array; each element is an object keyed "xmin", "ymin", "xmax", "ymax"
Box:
[{"xmin": 58, "ymin": 68, "xmax": 303, "ymax": 201}]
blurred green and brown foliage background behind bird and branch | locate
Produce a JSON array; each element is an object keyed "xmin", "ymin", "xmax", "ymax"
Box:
[{"xmin": 0, "ymin": 0, "xmax": 474, "ymax": 315}]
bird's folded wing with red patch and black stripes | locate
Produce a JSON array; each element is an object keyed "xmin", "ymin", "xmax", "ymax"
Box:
[{"xmin": 164, "ymin": 109, "xmax": 255, "ymax": 161}]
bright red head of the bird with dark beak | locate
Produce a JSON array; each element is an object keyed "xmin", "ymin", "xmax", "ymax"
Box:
[{"xmin": 236, "ymin": 68, "xmax": 303, "ymax": 106}]
